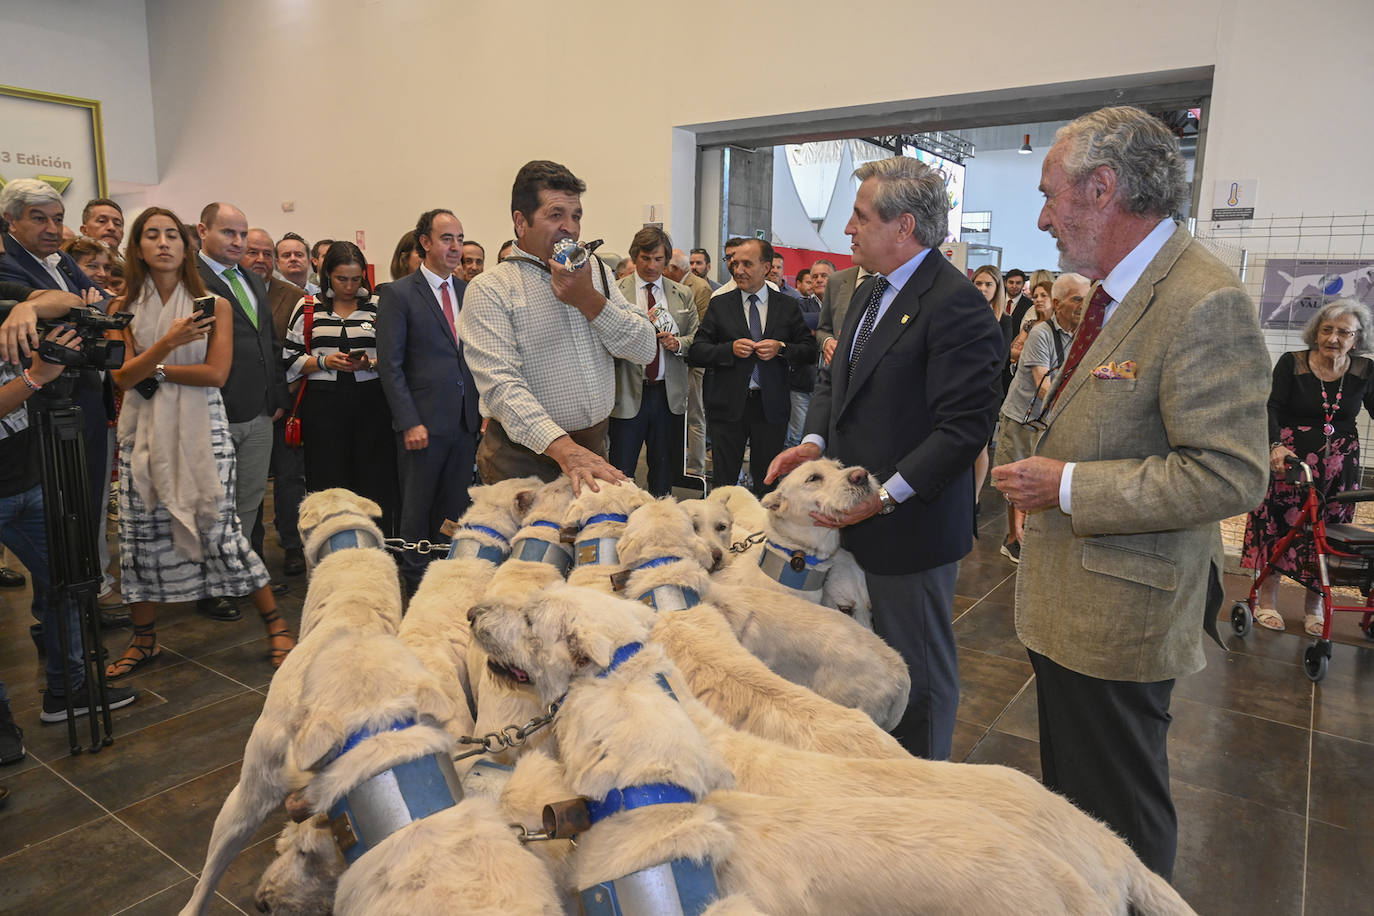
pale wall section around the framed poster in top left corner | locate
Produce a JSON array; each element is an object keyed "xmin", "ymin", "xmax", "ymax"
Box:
[{"xmin": 0, "ymin": 0, "xmax": 158, "ymax": 188}]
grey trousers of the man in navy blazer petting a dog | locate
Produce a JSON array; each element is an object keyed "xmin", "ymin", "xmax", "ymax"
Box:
[{"xmin": 864, "ymin": 562, "xmax": 959, "ymax": 761}]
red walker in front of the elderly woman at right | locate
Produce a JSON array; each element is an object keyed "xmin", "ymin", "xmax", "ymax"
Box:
[{"xmin": 1231, "ymin": 459, "xmax": 1374, "ymax": 683}]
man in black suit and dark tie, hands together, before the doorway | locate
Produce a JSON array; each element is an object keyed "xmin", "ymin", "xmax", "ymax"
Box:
[{"xmin": 687, "ymin": 239, "xmax": 816, "ymax": 496}]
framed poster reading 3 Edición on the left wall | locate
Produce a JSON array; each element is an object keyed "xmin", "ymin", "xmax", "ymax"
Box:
[{"xmin": 0, "ymin": 87, "xmax": 106, "ymax": 205}]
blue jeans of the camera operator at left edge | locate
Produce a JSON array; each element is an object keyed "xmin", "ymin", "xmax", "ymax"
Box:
[{"xmin": 0, "ymin": 486, "xmax": 85, "ymax": 699}]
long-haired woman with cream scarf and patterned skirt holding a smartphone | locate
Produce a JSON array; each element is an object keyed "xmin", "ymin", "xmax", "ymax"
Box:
[{"xmin": 106, "ymin": 207, "xmax": 295, "ymax": 677}]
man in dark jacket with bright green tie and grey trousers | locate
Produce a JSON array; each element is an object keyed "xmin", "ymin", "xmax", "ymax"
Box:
[{"xmin": 196, "ymin": 202, "xmax": 291, "ymax": 621}]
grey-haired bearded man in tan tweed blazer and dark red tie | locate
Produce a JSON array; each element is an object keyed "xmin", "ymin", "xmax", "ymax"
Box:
[{"xmin": 993, "ymin": 107, "xmax": 1270, "ymax": 878}]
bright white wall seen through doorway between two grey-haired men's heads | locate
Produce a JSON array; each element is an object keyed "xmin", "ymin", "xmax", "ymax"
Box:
[{"xmin": 963, "ymin": 147, "xmax": 1059, "ymax": 273}]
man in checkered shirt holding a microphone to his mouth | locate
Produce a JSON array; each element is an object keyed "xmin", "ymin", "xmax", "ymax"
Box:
[{"xmin": 459, "ymin": 159, "xmax": 658, "ymax": 492}]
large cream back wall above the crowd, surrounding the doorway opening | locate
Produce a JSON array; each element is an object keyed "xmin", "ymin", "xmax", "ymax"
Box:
[{"xmin": 61, "ymin": 0, "xmax": 1374, "ymax": 266}]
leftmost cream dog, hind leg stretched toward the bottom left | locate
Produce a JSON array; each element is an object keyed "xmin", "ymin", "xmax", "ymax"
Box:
[{"xmin": 181, "ymin": 489, "xmax": 406, "ymax": 915}]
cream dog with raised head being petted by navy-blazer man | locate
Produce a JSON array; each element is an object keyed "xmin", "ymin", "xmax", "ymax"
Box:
[{"xmin": 716, "ymin": 459, "xmax": 878, "ymax": 626}]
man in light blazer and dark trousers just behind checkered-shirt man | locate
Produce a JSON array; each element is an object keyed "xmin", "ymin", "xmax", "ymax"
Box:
[{"xmin": 609, "ymin": 227, "xmax": 697, "ymax": 496}]
